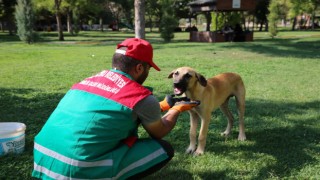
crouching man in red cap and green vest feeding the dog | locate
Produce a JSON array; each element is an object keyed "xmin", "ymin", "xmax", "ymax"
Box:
[{"xmin": 32, "ymin": 38, "xmax": 199, "ymax": 179}]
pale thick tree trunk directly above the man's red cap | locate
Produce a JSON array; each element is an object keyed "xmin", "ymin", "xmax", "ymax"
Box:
[{"xmin": 134, "ymin": 0, "xmax": 146, "ymax": 39}]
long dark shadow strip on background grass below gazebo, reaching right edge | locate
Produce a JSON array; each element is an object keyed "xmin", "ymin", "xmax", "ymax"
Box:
[{"xmin": 165, "ymin": 36, "xmax": 320, "ymax": 60}]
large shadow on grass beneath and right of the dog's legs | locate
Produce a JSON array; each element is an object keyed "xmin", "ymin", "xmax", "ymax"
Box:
[{"xmin": 170, "ymin": 99, "xmax": 320, "ymax": 179}]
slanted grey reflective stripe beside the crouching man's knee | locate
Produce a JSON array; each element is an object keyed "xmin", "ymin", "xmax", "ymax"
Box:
[{"xmin": 115, "ymin": 148, "xmax": 166, "ymax": 179}]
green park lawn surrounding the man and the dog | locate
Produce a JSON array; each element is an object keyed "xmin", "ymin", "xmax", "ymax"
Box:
[{"xmin": 0, "ymin": 31, "xmax": 320, "ymax": 180}]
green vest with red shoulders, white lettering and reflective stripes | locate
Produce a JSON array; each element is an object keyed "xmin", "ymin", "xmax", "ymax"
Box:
[{"xmin": 32, "ymin": 70, "xmax": 168, "ymax": 179}]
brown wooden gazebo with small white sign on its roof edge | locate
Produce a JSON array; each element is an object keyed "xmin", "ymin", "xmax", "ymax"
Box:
[{"xmin": 188, "ymin": 0, "xmax": 256, "ymax": 42}]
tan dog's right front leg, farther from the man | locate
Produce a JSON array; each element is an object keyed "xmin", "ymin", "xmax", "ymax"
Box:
[{"xmin": 194, "ymin": 113, "xmax": 210, "ymax": 156}]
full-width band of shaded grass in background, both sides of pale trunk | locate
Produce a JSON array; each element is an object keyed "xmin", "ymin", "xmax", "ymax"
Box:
[{"xmin": 0, "ymin": 31, "xmax": 320, "ymax": 59}]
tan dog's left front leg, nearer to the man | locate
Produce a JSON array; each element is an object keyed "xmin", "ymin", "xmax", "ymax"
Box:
[{"xmin": 186, "ymin": 111, "xmax": 199, "ymax": 154}]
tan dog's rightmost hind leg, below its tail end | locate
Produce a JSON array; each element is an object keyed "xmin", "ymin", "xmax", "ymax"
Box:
[{"xmin": 236, "ymin": 89, "xmax": 246, "ymax": 141}]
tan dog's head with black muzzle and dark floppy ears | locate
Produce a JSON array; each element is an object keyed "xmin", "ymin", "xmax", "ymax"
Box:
[{"xmin": 168, "ymin": 67, "xmax": 207, "ymax": 96}]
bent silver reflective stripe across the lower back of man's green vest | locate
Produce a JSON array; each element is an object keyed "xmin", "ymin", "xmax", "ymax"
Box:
[{"xmin": 34, "ymin": 143, "xmax": 113, "ymax": 167}]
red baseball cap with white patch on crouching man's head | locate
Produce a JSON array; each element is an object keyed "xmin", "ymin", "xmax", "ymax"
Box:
[{"xmin": 116, "ymin": 38, "xmax": 160, "ymax": 71}]
